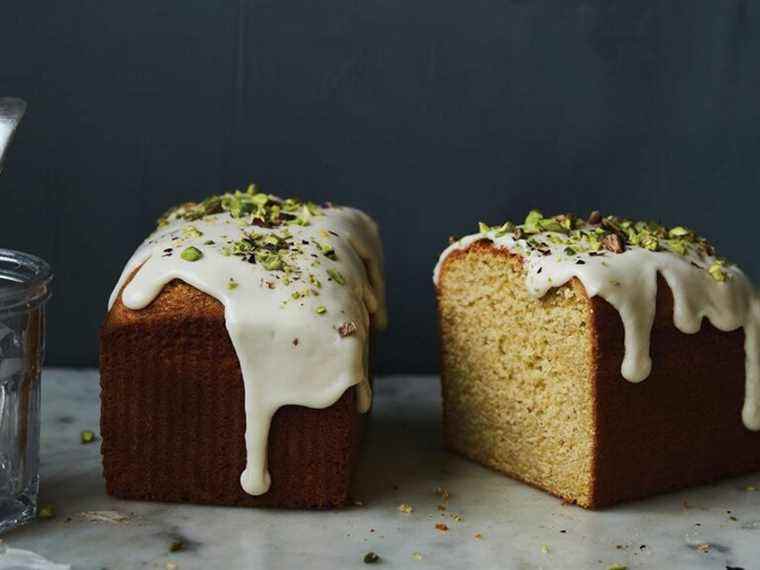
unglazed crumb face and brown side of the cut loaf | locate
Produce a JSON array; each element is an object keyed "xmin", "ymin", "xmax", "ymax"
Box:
[{"xmin": 437, "ymin": 240, "xmax": 760, "ymax": 508}]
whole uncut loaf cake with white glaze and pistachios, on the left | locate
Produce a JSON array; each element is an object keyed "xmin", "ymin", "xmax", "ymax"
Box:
[{"xmin": 100, "ymin": 185, "xmax": 386, "ymax": 508}]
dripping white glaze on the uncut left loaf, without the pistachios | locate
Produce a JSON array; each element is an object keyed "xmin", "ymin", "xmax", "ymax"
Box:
[{"xmin": 109, "ymin": 207, "xmax": 386, "ymax": 495}]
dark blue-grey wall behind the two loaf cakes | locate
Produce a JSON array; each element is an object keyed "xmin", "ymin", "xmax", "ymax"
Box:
[{"xmin": 0, "ymin": 0, "xmax": 760, "ymax": 372}]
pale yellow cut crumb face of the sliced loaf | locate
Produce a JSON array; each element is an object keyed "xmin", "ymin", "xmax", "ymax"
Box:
[{"xmin": 437, "ymin": 237, "xmax": 595, "ymax": 504}]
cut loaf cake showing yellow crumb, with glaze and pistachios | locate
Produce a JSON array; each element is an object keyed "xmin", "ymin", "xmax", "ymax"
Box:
[{"xmin": 434, "ymin": 211, "xmax": 760, "ymax": 508}]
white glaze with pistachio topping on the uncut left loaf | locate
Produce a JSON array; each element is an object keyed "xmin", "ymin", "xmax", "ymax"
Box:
[{"xmin": 110, "ymin": 185, "xmax": 386, "ymax": 495}]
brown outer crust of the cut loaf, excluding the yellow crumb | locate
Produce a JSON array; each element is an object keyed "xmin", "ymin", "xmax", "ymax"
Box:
[{"xmin": 437, "ymin": 239, "xmax": 760, "ymax": 508}]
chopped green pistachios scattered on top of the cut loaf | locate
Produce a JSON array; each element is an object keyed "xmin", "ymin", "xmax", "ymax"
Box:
[{"xmin": 470, "ymin": 210, "xmax": 730, "ymax": 281}]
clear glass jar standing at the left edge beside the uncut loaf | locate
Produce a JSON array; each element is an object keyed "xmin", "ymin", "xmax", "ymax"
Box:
[{"xmin": 0, "ymin": 249, "xmax": 52, "ymax": 532}]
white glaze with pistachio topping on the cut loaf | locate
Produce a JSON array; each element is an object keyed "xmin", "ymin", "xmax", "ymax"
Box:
[{"xmin": 433, "ymin": 206, "xmax": 760, "ymax": 430}]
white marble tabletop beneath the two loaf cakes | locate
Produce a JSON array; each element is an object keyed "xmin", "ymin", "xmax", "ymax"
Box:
[{"xmin": 3, "ymin": 369, "xmax": 760, "ymax": 570}]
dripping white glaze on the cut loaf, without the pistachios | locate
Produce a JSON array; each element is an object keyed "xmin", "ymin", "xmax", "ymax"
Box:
[{"xmin": 433, "ymin": 230, "xmax": 760, "ymax": 431}]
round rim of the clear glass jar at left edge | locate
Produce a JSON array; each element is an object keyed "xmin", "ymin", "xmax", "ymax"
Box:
[{"xmin": 0, "ymin": 248, "xmax": 53, "ymax": 313}]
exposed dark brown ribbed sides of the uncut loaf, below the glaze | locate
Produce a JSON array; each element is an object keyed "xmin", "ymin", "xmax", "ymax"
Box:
[{"xmin": 101, "ymin": 280, "xmax": 363, "ymax": 508}]
